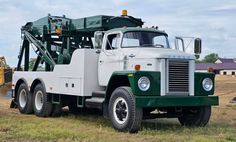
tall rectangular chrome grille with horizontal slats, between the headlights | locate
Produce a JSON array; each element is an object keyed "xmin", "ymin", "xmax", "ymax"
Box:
[{"xmin": 168, "ymin": 60, "xmax": 189, "ymax": 93}]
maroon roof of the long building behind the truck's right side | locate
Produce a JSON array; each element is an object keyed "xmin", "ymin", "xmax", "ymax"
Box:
[{"xmin": 195, "ymin": 63, "xmax": 236, "ymax": 70}]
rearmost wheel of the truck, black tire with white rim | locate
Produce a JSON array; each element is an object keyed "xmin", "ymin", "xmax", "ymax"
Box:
[{"xmin": 17, "ymin": 83, "xmax": 33, "ymax": 114}]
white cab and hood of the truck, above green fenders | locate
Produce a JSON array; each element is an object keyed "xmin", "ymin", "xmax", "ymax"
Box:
[{"xmin": 98, "ymin": 28, "xmax": 195, "ymax": 90}]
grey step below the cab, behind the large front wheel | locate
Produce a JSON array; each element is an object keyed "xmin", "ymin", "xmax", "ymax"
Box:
[{"xmin": 85, "ymin": 97, "xmax": 105, "ymax": 110}]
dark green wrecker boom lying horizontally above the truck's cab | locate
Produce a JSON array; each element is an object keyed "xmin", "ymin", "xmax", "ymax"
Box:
[{"xmin": 32, "ymin": 15, "xmax": 143, "ymax": 35}]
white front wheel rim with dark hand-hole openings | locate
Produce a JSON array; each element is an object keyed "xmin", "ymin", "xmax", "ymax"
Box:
[{"xmin": 113, "ymin": 97, "xmax": 129, "ymax": 124}]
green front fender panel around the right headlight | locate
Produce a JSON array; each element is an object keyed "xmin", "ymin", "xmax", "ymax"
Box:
[{"xmin": 194, "ymin": 72, "xmax": 215, "ymax": 96}]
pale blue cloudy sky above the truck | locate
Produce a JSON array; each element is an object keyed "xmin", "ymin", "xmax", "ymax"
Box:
[{"xmin": 0, "ymin": 0, "xmax": 236, "ymax": 67}]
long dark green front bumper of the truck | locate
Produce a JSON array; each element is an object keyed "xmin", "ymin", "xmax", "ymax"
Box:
[{"xmin": 135, "ymin": 96, "xmax": 219, "ymax": 108}]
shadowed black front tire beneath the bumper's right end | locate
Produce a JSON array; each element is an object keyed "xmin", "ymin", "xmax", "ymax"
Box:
[{"xmin": 178, "ymin": 106, "xmax": 211, "ymax": 127}]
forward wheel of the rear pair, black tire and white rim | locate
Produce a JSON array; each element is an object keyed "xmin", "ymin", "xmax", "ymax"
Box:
[{"xmin": 33, "ymin": 84, "xmax": 52, "ymax": 117}]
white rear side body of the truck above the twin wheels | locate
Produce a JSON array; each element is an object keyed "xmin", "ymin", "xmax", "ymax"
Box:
[{"xmin": 13, "ymin": 49, "xmax": 101, "ymax": 96}]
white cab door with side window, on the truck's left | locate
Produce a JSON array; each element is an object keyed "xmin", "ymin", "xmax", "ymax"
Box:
[{"xmin": 98, "ymin": 32, "xmax": 121, "ymax": 86}]
